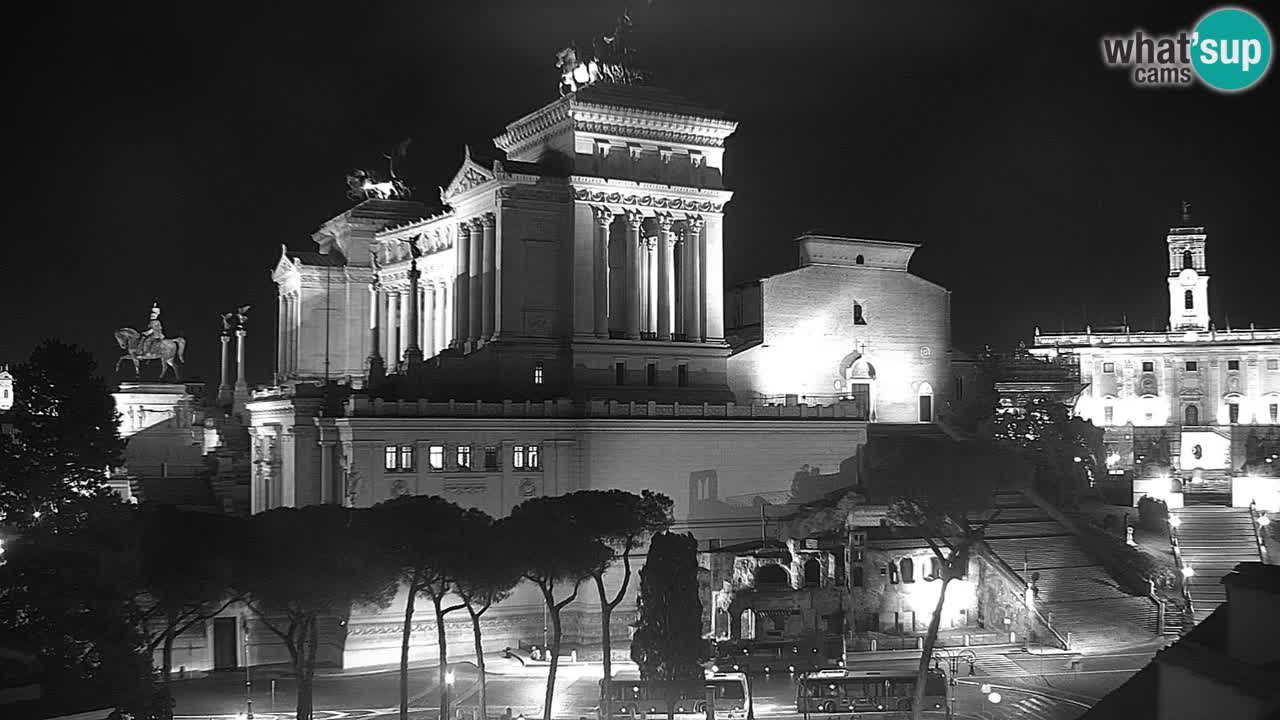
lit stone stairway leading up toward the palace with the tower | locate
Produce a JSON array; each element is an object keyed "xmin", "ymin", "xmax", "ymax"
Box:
[{"xmin": 1174, "ymin": 505, "xmax": 1263, "ymax": 623}]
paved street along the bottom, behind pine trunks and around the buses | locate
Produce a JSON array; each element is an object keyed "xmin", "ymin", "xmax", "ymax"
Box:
[{"xmin": 174, "ymin": 643, "xmax": 1160, "ymax": 720}]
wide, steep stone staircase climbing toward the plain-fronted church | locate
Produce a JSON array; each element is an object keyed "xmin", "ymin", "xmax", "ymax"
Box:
[{"xmin": 987, "ymin": 492, "xmax": 1158, "ymax": 650}]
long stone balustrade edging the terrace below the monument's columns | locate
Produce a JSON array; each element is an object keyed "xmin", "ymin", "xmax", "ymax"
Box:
[{"xmin": 344, "ymin": 396, "xmax": 867, "ymax": 420}]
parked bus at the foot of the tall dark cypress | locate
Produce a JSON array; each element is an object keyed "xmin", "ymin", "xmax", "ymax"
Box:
[{"xmin": 600, "ymin": 673, "xmax": 755, "ymax": 720}]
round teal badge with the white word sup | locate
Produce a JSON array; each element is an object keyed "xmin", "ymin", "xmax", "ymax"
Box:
[{"xmin": 1192, "ymin": 8, "xmax": 1271, "ymax": 92}]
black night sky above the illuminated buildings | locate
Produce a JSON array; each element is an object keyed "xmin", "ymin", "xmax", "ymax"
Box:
[{"xmin": 0, "ymin": 0, "xmax": 1280, "ymax": 392}]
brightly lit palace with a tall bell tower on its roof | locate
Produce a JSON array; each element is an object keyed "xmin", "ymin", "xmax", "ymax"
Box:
[{"xmin": 1030, "ymin": 206, "xmax": 1280, "ymax": 509}]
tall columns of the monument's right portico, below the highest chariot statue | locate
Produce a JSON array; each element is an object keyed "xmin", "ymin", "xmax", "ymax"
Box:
[{"xmin": 591, "ymin": 206, "xmax": 723, "ymax": 342}]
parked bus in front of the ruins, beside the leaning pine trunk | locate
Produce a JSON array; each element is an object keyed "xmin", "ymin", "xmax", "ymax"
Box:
[{"xmin": 796, "ymin": 669, "xmax": 947, "ymax": 714}]
